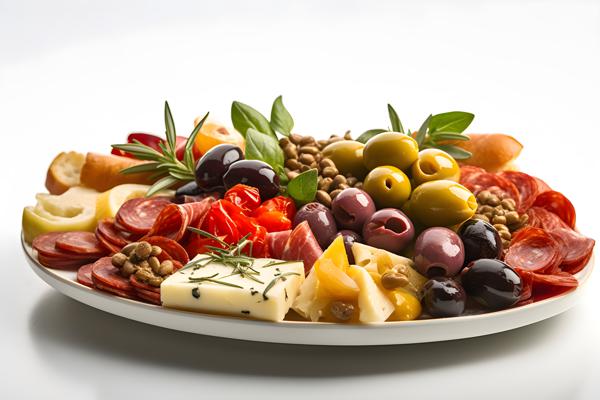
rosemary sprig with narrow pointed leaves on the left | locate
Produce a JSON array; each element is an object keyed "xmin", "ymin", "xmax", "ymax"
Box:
[{"xmin": 112, "ymin": 101, "xmax": 208, "ymax": 196}]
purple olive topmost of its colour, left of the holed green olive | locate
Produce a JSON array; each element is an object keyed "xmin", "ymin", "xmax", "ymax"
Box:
[{"xmin": 331, "ymin": 188, "xmax": 375, "ymax": 231}]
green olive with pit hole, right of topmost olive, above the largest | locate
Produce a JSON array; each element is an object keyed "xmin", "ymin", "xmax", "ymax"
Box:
[{"xmin": 411, "ymin": 149, "xmax": 460, "ymax": 185}]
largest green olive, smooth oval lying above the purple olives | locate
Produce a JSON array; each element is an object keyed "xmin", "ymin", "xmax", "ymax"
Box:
[{"xmin": 404, "ymin": 180, "xmax": 477, "ymax": 227}]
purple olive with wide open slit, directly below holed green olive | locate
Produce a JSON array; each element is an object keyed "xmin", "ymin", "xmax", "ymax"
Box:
[{"xmin": 363, "ymin": 208, "xmax": 415, "ymax": 253}]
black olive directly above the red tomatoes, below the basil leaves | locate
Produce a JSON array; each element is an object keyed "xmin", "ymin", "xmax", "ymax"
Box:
[{"xmin": 223, "ymin": 160, "xmax": 279, "ymax": 201}]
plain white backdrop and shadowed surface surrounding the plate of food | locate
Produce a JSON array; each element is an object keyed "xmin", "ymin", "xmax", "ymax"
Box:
[{"xmin": 0, "ymin": 0, "xmax": 600, "ymax": 399}]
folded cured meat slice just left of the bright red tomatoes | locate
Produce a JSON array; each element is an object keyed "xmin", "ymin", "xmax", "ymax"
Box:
[{"xmin": 148, "ymin": 197, "xmax": 215, "ymax": 241}]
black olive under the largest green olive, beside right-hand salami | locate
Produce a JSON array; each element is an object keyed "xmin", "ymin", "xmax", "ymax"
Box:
[{"xmin": 458, "ymin": 219, "xmax": 502, "ymax": 265}]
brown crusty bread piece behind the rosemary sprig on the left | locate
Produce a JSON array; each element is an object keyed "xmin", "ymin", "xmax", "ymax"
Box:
[{"xmin": 80, "ymin": 153, "xmax": 154, "ymax": 192}]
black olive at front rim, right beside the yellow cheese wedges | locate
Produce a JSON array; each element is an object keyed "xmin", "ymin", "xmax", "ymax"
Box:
[{"xmin": 421, "ymin": 276, "xmax": 467, "ymax": 317}]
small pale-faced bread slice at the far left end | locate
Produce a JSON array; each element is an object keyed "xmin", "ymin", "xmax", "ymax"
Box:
[{"xmin": 46, "ymin": 151, "xmax": 85, "ymax": 194}]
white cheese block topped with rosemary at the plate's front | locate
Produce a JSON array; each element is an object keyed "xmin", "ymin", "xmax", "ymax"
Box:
[{"xmin": 160, "ymin": 260, "xmax": 304, "ymax": 321}]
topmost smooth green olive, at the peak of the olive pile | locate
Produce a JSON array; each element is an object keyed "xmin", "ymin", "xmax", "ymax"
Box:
[{"xmin": 363, "ymin": 132, "xmax": 419, "ymax": 171}]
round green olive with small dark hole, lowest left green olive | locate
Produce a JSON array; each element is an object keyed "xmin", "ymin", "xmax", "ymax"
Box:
[{"xmin": 363, "ymin": 165, "xmax": 410, "ymax": 208}]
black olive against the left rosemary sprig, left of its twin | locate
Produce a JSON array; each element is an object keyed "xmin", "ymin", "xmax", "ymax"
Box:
[{"xmin": 196, "ymin": 144, "xmax": 244, "ymax": 190}]
